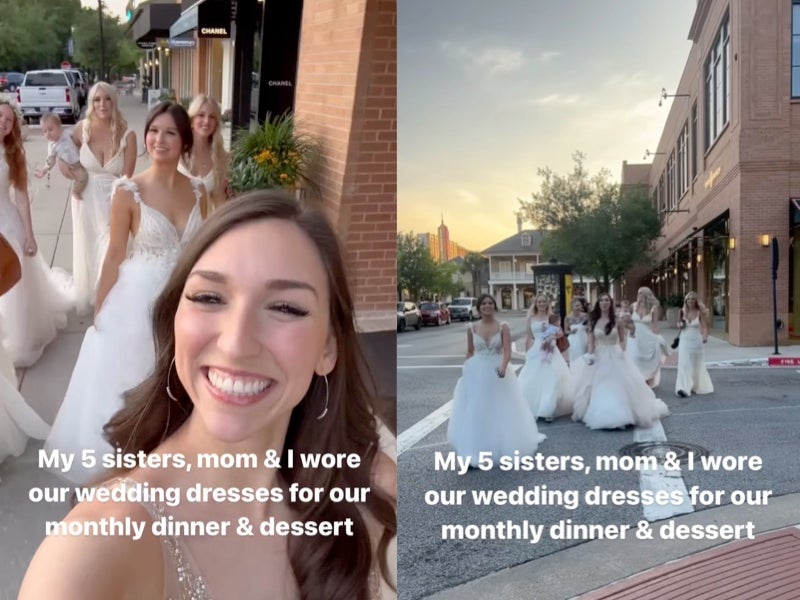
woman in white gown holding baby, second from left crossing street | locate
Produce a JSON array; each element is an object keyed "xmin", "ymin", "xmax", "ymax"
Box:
[{"xmin": 519, "ymin": 294, "xmax": 572, "ymax": 421}]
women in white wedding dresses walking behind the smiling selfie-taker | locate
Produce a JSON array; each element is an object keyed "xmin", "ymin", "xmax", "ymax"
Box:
[{"xmin": 0, "ymin": 82, "xmax": 227, "ymax": 483}]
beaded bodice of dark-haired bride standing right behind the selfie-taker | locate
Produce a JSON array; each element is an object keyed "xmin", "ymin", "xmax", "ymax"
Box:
[{"xmin": 111, "ymin": 177, "xmax": 202, "ymax": 259}]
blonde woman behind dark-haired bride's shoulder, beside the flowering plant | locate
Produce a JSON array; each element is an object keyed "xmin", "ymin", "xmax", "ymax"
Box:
[{"xmin": 178, "ymin": 94, "xmax": 228, "ymax": 216}]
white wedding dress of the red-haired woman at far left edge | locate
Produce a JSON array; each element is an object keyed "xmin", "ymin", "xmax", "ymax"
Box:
[{"xmin": 0, "ymin": 152, "xmax": 74, "ymax": 367}]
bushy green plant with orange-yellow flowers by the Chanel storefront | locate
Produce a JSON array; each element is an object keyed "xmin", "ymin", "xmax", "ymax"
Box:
[{"xmin": 228, "ymin": 112, "xmax": 319, "ymax": 195}]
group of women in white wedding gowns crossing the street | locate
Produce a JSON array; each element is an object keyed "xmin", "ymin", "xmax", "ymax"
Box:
[{"xmin": 448, "ymin": 288, "xmax": 713, "ymax": 465}]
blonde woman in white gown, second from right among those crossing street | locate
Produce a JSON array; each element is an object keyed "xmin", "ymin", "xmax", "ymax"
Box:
[{"xmin": 626, "ymin": 287, "xmax": 669, "ymax": 388}]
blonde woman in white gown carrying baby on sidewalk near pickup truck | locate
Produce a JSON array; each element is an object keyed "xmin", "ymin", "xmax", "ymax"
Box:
[{"xmin": 65, "ymin": 81, "xmax": 136, "ymax": 315}]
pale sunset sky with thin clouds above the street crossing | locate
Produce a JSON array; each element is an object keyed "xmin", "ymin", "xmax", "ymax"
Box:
[{"xmin": 397, "ymin": 0, "xmax": 696, "ymax": 251}]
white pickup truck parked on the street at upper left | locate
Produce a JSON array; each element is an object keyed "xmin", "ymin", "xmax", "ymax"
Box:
[{"xmin": 17, "ymin": 69, "xmax": 81, "ymax": 123}]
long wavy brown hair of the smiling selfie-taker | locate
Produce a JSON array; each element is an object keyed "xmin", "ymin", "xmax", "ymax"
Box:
[{"xmin": 105, "ymin": 190, "xmax": 397, "ymax": 600}]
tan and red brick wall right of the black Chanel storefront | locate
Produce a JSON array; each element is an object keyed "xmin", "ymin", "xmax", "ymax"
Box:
[{"xmin": 295, "ymin": 0, "xmax": 397, "ymax": 333}]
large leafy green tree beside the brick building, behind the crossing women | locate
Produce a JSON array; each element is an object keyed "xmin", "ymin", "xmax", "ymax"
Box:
[{"xmin": 519, "ymin": 152, "xmax": 661, "ymax": 288}]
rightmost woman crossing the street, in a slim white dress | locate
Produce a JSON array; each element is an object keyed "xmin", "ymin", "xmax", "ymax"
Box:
[{"xmin": 675, "ymin": 292, "xmax": 714, "ymax": 398}]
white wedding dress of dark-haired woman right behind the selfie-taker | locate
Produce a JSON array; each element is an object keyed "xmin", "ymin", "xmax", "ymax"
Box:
[{"xmin": 45, "ymin": 178, "xmax": 202, "ymax": 483}]
